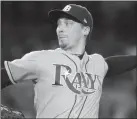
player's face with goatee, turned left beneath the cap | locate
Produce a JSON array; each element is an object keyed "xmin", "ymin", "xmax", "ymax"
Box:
[{"xmin": 56, "ymin": 18, "xmax": 83, "ymax": 49}]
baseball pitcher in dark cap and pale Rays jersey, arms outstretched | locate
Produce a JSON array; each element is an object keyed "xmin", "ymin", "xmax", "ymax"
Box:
[{"xmin": 1, "ymin": 4, "xmax": 137, "ymax": 118}]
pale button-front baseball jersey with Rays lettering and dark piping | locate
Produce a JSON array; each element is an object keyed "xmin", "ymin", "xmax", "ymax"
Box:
[{"xmin": 4, "ymin": 48, "xmax": 108, "ymax": 118}]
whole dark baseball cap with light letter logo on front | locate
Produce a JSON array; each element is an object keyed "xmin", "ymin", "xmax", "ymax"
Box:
[{"xmin": 48, "ymin": 4, "xmax": 93, "ymax": 27}]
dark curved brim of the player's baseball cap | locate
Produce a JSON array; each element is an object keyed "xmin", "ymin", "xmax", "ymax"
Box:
[{"xmin": 48, "ymin": 9, "xmax": 81, "ymax": 23}]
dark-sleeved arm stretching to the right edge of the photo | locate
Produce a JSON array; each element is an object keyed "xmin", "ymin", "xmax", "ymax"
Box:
[{"xmin": 105, "ymin": 55, "xmax": 137, "ymax": 77}]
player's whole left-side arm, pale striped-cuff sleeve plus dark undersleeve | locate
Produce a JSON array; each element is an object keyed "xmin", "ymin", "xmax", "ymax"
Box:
[{"xmin": 1, "ymin": 53, "xmax": 39, "ymax": 89}]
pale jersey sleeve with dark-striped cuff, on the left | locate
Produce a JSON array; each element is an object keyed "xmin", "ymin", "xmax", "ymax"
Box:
[{"xmin": 4, "ymin": 51, "xmax": 42, "ymax": 84}]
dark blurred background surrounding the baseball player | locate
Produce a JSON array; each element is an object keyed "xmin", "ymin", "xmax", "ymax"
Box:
[{"xmin": 1, "ymin": 1, "xmax": 137, "ymax": 118}]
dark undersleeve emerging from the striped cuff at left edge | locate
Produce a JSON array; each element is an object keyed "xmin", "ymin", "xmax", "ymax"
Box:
[{"xmin": 1, "ymin": 68, "xmax": 12, "ymax": 89}]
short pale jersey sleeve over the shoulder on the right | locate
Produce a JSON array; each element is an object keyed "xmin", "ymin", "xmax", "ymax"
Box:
[{"xmin": 92, "ymin": 54, "xmax": 108, "ymax": 78}]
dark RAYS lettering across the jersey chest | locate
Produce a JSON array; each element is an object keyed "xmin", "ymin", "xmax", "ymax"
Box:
[{"xmin": 53, "ymin": 64, "xmax": 101, "ymax": 94}]
